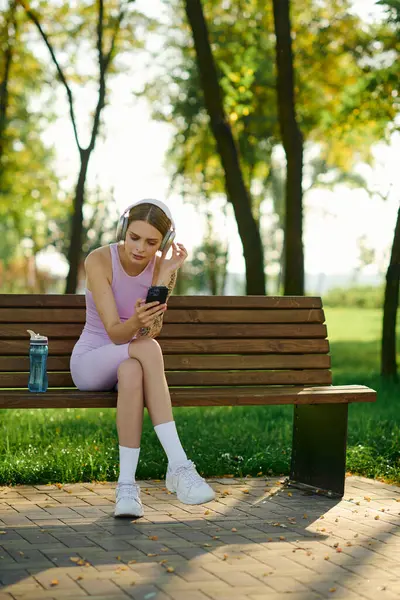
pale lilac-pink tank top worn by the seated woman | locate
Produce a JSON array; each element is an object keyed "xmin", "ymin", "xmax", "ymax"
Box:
[{"xmin": 82, "ymin": 243, "xmax": 156, "ymax": 341}]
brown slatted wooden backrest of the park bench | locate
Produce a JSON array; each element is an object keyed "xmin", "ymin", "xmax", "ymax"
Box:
[{"xmin": 0, "ymin": 294, "xmax": 332, "ymax": 388}]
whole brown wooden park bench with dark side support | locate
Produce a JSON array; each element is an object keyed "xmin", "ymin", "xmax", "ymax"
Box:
[{"xmin": 0, "ymin": 294, "xmax": 376, "ymax": 496}]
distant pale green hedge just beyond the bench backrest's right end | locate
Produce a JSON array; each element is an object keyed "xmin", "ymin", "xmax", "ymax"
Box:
[{"xmin": 323, "ymin": 285, "xmax": 385, "ymax": 308}]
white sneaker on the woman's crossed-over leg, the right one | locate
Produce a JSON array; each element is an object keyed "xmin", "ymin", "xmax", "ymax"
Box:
[{"xmin": 166, "ymin": 460, "xmax": 215, "ymax": 504}]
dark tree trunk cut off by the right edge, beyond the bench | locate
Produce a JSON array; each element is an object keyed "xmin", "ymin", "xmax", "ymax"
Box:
[{"xmin": 381, "ymin": 208, "xmax": 400, "ymax": 381}]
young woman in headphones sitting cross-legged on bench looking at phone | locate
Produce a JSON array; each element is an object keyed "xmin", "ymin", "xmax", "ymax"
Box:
[{"xmin": 71, "ymin": 200, "xmax": 215, "ymax": 517}]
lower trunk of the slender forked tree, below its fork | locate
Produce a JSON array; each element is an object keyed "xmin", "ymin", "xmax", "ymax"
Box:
[{"xmin": 65, "ymin": 149, "xmax": 91, "ymax": 294}]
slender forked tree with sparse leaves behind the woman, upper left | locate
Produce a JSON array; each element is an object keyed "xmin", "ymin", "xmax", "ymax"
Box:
[{"xmin": 17, "ymin": 0, "xmax": 150, "ymax": 293}]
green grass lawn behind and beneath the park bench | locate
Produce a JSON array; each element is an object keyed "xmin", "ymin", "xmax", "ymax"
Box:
[{"xmin": 0, "ymin": 308, "xmax": 400, "ymax": 484}]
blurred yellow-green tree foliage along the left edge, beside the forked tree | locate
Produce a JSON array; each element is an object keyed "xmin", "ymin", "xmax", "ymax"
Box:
[{"xmin": 0, "ymin": 1, "xmax": 61, "ymax": 270}]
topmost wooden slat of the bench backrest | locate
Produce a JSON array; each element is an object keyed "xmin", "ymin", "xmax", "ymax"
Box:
[{"xmin": 0, "ymin": 294, "xmax": 322, "ymax": 310}]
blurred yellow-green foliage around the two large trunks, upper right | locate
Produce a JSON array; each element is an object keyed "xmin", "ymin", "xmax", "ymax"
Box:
[{"xmin": 143, "ymin": 0, "xmax": 398, "ymax": 292}]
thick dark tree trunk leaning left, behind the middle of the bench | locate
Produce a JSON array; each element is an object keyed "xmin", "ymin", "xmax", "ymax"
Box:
[{"xmin": 185, "ymin": 0, "xmax": 265, "ymax": 295}]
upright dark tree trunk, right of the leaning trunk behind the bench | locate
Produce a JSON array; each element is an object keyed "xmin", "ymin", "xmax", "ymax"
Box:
[{"xmin": 273, "ymin": 0, "xmax": 304, "ymax": 295}]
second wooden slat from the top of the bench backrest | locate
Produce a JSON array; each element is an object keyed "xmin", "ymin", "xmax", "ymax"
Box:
[{"xmin": 0, "ymin": 302, "xmax": 325, "ymax": 329}]
